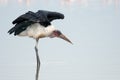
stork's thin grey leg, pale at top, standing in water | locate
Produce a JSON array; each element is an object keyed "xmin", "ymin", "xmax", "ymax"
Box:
[{"xmin": 35, "ymin": 39, "xmax": 40, "ymax": 80}]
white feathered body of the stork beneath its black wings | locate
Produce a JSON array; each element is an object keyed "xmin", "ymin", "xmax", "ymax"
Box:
[{"xmin": 19, "ymin": 23, "xmax": 55, "ymax": 39}]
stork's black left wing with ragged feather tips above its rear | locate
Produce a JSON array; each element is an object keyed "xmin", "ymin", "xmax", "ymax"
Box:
[{"xmin": 8, "ymin": 11, "xmax": 38, "ymax": 35}]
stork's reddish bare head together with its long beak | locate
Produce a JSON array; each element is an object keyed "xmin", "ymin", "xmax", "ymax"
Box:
[{"xmin": 50, "ymin": 30, "xmax": 72, "ymax": 44}]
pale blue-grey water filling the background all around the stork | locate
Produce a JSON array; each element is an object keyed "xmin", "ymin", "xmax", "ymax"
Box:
[{"xmin": 0, "ymin": 0, "xmax": 120, "ymax": 80}]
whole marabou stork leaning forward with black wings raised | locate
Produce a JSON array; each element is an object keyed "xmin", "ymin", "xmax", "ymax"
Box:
[{"xmin": 8, "ymin": 10, "xmax": 72, "ymax": 80}]
